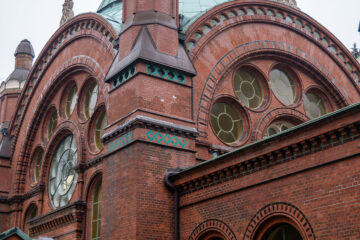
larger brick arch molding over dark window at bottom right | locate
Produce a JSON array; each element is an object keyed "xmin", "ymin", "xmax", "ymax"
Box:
[{"xmin": 243, "ymin": 202, "xmax": 315, "ymax": 240}]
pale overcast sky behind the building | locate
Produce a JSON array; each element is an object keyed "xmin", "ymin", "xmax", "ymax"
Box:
[{"xmin": 0, "ymin": 0, "xmax": 360, "ymax": 82}]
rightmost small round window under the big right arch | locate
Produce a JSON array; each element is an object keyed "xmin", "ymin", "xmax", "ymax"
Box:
[{"xmin": 304, "ymin": 93, "xmax": 327, "ymax": 119}]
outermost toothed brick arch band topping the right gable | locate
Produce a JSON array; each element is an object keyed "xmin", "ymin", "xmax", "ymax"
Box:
[{"xmin": 186, "ymin": 0, "xmax": 360, "ymax": 85}]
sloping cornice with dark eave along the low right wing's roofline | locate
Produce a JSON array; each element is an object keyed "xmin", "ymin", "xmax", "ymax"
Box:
[{"xmin": 174, "ymin": 104, "xmax": 360, "ymax": 195}]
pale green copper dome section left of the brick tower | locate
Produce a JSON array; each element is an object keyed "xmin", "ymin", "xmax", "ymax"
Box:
[{"xmin": 96, "ymin": 0, "xmax": 123, "ymax": 34}]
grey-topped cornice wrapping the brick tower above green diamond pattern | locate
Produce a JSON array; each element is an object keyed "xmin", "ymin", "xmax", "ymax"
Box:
[{"xmin": 102, "ymin": 115, "xmax": 198, "ymax": 143}]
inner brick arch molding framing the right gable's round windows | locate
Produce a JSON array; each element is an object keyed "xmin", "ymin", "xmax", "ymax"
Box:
[{"xmin": 197, "ymin": 40, "xmax": 352, "ymax": 137}]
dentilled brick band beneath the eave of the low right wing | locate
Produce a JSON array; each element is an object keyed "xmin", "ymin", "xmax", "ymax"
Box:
[{"xmin": 178, "ymin": 121, "xmax": 360, "ymax": 195}]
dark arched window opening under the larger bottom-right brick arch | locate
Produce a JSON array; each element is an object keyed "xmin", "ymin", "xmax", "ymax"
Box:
[{"xmin": 261, "ymin": 223, "xmax": 302, "ymax": 240}]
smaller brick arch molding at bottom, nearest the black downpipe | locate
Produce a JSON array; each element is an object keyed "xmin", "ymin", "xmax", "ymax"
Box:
[{"xmin": 189, "ymin": 219, "xmax": 237, "ymax": 240}]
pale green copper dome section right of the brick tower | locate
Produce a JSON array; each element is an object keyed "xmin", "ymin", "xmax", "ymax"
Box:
[{"xmin": 179, "ymin": 0, "xmax": 233, "ymax": 31}]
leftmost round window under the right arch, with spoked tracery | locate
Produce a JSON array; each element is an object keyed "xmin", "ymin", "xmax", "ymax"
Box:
[{"xmin": 210, "ymin": 103, "xmax": 243, "ymax": 144}]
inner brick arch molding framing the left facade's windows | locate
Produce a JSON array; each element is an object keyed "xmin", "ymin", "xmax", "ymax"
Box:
[{"xmin": 13, "ymin": 55, "xmax": 105, "ymax": 193}]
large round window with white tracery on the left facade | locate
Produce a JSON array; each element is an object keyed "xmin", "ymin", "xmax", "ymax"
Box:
[{"xmin": 49, "ymin": 135, "xmax": 78, "ymax": 208}]
